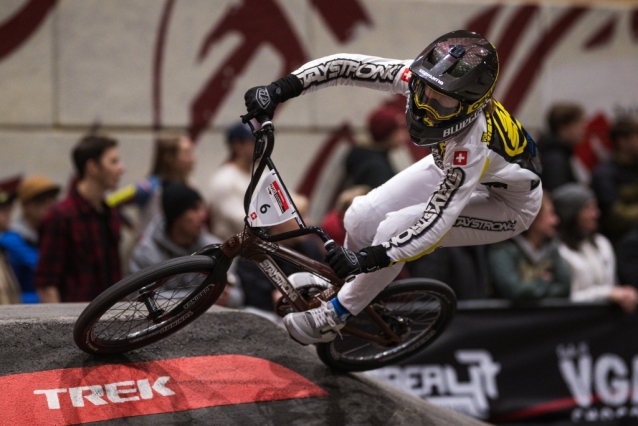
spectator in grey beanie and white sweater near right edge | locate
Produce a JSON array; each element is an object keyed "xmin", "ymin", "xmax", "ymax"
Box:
[{"xmin": 551, "ymin": 183, "xmax": 638, "ymax": 312}]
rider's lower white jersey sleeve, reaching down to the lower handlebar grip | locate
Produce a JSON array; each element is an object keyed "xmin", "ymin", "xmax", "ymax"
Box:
[{"xmin": 382, "ymin": 138, "xmax": 490, "ymax": 264}]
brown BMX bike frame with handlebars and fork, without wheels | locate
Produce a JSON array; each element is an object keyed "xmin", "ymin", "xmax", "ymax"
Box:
[{"xmin": 202, "ymin": 121, "xmax": 401, "ymax": 345}]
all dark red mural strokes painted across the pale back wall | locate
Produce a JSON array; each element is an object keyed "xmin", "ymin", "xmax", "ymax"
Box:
[{"xmin": 0, "ymin": 0, "xmax": 638, "ymax": 210}]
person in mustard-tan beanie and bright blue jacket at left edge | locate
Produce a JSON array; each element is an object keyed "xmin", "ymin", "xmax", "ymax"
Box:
[{"xmin": 0, "ymin": 175, "xmax": 60, "ymax": 303}]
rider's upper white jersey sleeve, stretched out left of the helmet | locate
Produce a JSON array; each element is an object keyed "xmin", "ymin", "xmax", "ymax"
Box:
[{"xmin": 292, "ymin": 53, "xmax": 412, "ymax": 95}]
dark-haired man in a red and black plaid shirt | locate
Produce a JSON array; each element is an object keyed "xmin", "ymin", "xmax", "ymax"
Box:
[{"xmin": 35, "ymin": 135, "xmax": 124, "ymax": 303}]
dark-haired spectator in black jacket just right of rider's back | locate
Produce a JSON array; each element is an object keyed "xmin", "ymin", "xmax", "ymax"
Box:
[{"xmin": 538, "ymin": 103, "xmax": 585, "ymax": 191}]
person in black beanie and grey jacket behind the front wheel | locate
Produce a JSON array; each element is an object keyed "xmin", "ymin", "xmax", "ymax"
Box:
[{"xmin": 129, "ymin": 182, "xmax": 243, "ymax": 308}]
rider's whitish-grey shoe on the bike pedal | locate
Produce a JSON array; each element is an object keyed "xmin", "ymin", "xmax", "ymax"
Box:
[{"xmin": 284, "ymin": 300, "xmax": 345, "ymax": 345}]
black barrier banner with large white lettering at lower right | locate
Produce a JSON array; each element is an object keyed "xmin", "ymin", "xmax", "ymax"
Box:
[{"xmin": 368, "ymin": 302, "xmax": 638, "ymax": 426}]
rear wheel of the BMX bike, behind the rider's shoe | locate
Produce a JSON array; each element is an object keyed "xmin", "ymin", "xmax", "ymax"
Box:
[{"xmin": 316, "ymin": 278, "xmax": 456, "ymax": 371}]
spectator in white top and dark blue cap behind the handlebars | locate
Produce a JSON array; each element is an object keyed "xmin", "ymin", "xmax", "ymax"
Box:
[{"xmin": 207, "ymin": 123, "xmax": 255, "ymax": 238}]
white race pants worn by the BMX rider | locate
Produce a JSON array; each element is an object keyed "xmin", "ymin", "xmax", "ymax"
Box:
[{"xmin": 339, "ymin": 155, "xmax": 543, "ymax": 315}]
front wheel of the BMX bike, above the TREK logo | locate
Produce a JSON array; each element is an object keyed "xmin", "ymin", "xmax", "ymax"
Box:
[{"xmin": 73, "ymin": 251, "xmax": 230, "ymax": 355}]
